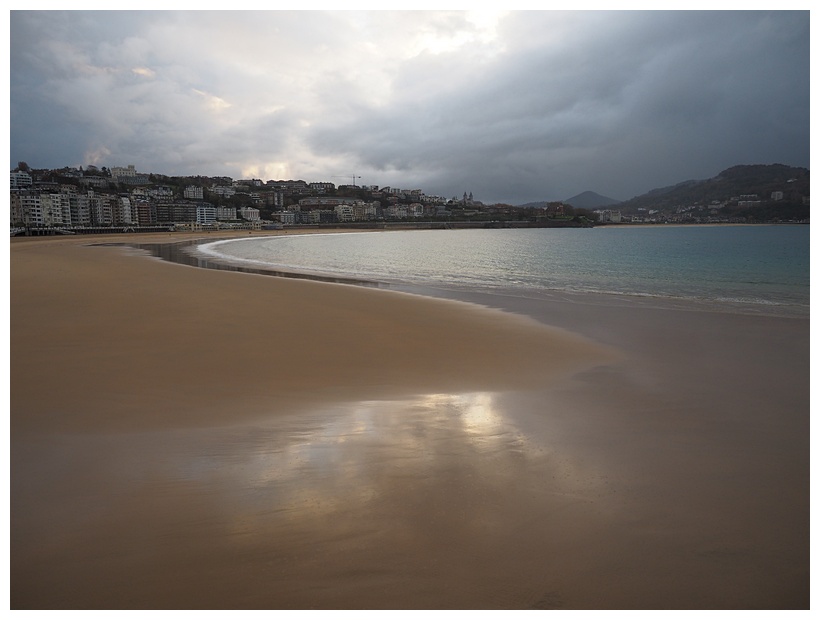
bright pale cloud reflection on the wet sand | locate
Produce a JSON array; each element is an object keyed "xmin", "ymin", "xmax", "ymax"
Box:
[{"xmin": 232, "ymin": 393, "xmax": 543, "ymax": 512}]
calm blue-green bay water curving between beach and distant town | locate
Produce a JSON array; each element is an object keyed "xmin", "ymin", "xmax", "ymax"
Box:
[{"xmin": 199, "ymin": 225, "xmax": 810, "ymax": 315}]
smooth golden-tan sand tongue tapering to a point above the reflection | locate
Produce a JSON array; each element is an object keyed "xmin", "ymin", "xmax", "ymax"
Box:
[{"xmin": 12, "ymin": 232, "xmax": 611, "ymax": 436}]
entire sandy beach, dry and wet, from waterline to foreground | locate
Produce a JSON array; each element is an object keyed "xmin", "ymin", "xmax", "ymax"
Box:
[{"xmin": 10, "ymin": 235, "xmax": 810, "ymax": 609}]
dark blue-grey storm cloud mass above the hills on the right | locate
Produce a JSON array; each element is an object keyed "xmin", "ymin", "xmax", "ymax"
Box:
[{"xmin": 304, "ymin": 13, "xmax": 809, "ymax": 198}]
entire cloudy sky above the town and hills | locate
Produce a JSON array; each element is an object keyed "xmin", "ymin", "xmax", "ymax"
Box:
[{"xmin": 9, "ymin": 10, "xmax": 810, "ymax": 204}]
